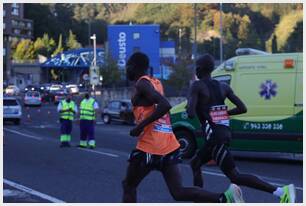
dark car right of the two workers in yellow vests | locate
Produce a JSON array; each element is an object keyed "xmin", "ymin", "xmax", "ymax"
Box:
[{"xmin": 101, "ymin": 100, "xmax": 135, "ymax": 124}]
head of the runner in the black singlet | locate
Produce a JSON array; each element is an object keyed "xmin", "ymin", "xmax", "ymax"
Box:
[{"xmin": 196, "ymin": 54, "xmax": 215, "ymax": 79}]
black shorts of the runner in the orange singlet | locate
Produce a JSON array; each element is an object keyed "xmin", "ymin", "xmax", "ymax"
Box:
[{"xmin": 128, "ymin": 149, "xmax": 182, "ymax": 170}]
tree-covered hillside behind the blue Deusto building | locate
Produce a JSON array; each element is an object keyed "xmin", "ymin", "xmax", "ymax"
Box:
[{"xmin": 20, "ymin": 3, "xmax": 303, "ymax": 59}]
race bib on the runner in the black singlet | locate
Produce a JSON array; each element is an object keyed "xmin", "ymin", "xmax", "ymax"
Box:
[{"xmin": 209, "ymin": 105, "xmax": 229, "ymax": 126}]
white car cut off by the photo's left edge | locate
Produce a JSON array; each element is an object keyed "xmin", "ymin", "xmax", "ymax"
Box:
[{"xmin": 3, "ymin": 97, "xmax": 22, "ymax": 125}]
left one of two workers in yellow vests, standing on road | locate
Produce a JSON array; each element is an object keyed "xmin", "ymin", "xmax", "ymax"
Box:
[{"xmin": 57, "ymin": 94, "xmax": 78, "ymax": 147}]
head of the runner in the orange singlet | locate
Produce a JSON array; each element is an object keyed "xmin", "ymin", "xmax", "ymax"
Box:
[{"xmin": 126, "ymin": 52, "xmax": 149, "ymax": 81}]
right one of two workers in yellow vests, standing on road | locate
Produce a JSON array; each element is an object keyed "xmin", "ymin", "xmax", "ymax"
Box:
[{"xmin": 79, "ymin": 93, "xmax": 99, "ymax": 149}]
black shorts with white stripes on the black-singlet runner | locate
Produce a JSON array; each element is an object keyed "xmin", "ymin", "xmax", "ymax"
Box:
[{"xmin": 197, "ymin": 126, "xmax": 236, "ymax": 173}]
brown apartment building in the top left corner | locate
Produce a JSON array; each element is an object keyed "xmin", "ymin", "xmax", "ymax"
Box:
[{"xmin": 3, "ymin": 3, "xmax": 33, "ymax": 83}]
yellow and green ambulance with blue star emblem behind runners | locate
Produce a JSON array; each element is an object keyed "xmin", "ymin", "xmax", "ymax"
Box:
[{"xmin": 170, "ymin": 53, "xmax": 303, "ymax": 158}]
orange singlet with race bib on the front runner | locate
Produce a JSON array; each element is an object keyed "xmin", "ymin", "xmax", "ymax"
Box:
[{"xmin": 133, "ymin": 75, "xmax": 180, "ymax": 155}]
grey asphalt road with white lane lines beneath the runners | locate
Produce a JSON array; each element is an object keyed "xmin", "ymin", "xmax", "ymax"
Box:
[{"xmin": 3, "ymin": 104, "xmax": 303, "ymax": 203}]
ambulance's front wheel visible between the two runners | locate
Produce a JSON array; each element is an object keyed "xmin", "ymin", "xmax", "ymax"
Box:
[{"xmin": 174, "ymin": 130, "xmax": 196, "ymax": 158}]
